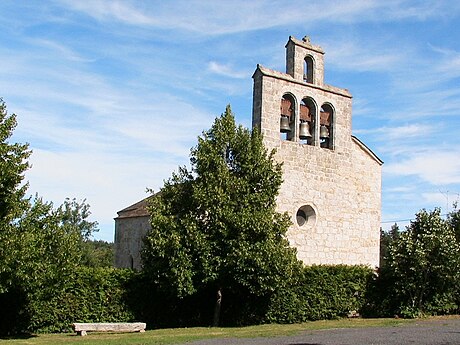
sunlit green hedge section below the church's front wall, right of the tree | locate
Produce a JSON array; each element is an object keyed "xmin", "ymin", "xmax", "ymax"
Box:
[{"xmin": 266, "ymin": 265, "xmax": 374, "ymax": 323}]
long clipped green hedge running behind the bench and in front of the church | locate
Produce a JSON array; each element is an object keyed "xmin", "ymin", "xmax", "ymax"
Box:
[{"xmin": 0, "ymin": 266, "xmax": 372, "ymax": 334}]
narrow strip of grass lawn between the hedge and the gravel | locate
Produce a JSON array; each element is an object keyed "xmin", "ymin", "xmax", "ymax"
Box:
[{"xmin": 0, "ymin": 319, "xmax": 424, "ymax": 345}]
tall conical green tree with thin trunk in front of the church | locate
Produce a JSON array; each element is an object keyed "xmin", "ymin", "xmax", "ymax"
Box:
[{"xmin": 142, "ymin": 106, "xmax": 300, "ymax": 325}]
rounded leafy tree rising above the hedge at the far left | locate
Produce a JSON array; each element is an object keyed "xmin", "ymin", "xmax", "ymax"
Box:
[{"xmin": 0, "ymin": 196, "xmax": 97, "ymax": 291}]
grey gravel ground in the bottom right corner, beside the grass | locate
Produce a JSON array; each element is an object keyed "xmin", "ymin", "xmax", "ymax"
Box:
[{"xmin": 187, "ymin": 319, "xmax": 460, "ymax": 345}]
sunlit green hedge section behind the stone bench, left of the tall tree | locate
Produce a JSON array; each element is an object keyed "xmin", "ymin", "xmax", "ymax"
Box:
[{"xmin": 0, "ymin": 267, "xmax": 136, "ymax": 334}]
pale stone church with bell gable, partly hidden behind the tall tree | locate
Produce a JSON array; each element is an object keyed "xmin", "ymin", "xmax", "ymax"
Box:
[{"xmin": 115, "ymin": 36, "xmax": 383, "ymax": 268}]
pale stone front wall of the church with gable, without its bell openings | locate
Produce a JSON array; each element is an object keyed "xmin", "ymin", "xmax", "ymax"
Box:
[{"xmin": 253, "ymin": 38, "xmax": 382, "ymax": 267}]
